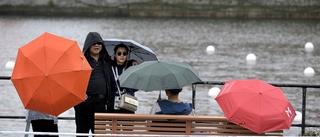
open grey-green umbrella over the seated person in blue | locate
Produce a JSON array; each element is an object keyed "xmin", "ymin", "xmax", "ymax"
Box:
[{"xmin": 119, "ymin": 61, "xmax": 201, "ymax": 91}]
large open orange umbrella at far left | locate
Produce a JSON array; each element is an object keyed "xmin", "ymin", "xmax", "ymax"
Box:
[{"xmin": 11, "ymin": 32, "xmax": 92, "ymax": 116}]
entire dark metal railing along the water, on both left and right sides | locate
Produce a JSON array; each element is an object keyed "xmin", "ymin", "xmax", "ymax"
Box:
[{"xmin": 0, "ymin": 76, "xmax": 320, "ymax": 135}]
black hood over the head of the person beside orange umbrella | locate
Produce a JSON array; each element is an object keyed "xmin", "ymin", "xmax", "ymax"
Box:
[{"xmin": 82, "ymin": 32, "xmax": 110, "ymax": 58}]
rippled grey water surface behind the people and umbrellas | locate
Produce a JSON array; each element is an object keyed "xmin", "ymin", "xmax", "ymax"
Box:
[{"xmin": 0, "ymin": 17, "xmax": 320, "ymax": 135}]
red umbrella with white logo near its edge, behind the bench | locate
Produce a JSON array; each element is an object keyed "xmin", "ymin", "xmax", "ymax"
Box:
[{"xmin": 216, "ymin": 79, "xmax": 296, "ymax": 133}]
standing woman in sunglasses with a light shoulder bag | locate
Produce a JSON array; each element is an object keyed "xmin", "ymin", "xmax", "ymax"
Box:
[{"xmin": 107, "ymin": 44, "xmax": 137, "ymax": 113}]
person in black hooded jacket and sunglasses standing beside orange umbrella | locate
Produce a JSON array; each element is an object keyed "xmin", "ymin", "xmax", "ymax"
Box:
[{"xmin": 74, "ymin": 32, "xmax": 112, "ymax": 133}]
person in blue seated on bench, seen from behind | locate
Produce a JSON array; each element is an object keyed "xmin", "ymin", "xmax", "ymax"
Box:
[{"xmin": 150, "ymin": 88, "xmax": 195, "ymax": 115}]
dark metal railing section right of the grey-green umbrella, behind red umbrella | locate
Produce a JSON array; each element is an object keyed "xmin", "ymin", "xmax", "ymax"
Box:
[{"xmin": 192, "ymin": 81, "xmax": 320, "ymax": 135}]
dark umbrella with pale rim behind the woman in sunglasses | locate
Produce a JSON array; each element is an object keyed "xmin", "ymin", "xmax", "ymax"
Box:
[{"xmin": 103, "ymin": 39, "xmax": 158, "ymax": 64}]
